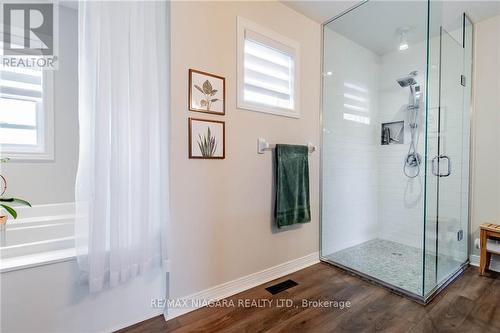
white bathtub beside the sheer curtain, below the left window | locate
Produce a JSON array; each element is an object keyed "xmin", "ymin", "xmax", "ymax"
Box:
[{"xmin": 0, "ymin": 202, "xmax": 75, "ymax": 272}]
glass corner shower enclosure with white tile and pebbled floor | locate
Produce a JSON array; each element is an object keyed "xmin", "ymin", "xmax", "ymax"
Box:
[{"xmin": 321, "ymin": 1, "xmax": 473, "ymax": 303}]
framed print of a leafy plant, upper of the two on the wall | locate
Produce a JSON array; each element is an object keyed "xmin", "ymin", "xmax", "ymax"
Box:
[{"xmin": 188, "ymin": 69, "xmax": 226, "ymax": 115}]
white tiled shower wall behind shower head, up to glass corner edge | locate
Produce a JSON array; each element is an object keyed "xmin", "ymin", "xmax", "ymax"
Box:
[{"xmin": 377, "ymin": 43, "xmax": 426, "ymax": 248}]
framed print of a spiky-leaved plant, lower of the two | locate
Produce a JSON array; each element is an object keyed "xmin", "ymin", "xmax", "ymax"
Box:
[{"xmin": 188, "ymin": 118, "xmax": 226, "ymax": 159}]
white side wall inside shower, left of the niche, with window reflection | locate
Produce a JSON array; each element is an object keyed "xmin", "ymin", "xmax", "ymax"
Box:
[{"xmin": 321, "ymin": 28, "xmax": 380, "ymax": 255}]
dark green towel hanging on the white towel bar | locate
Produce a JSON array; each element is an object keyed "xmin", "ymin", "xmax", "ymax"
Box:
[{"xmin": 274, "ymin": 144, "xmax": 311, "ymax": 228}]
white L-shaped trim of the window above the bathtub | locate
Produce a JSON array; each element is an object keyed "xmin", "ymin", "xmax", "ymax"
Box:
[{"xmin": 1, "ymin": 70, "xmax": 54, "ymax": 161}]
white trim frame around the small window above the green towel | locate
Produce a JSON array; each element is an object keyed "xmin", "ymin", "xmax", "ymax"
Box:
[{"xmin": 237, "ymin": 16, "xmax": 301, "ymax": 118}]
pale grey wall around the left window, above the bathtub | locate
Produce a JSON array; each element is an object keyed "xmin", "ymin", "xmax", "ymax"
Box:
[{"xmin": 1, "ymin": 7, "xmax": 78, "ymax": 204}]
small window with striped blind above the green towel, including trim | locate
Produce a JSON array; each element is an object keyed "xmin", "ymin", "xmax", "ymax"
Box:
[{"xmin": 238, "ymin": 17, "xmax": 300, "ymax": 118}]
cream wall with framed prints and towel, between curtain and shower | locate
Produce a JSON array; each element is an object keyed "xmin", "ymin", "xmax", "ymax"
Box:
[{"xmin": 170, "ymin": 1, "xmax": 321, "ymax": 297}]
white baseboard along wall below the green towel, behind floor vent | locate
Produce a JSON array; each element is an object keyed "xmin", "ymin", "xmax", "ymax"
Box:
[{"xmin": 165, "ymin": 252, "xmax": 319, "ymax": 320}]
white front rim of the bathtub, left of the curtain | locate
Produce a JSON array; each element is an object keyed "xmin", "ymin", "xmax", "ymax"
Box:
[{"xmin": 0, "ymin": 248, "xmax": 76, "ymax": 273}]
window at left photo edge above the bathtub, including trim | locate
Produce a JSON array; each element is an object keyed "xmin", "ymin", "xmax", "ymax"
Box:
[{"xmin": 0, "ymin": 47, "xmax": 53, "ymax": 159}]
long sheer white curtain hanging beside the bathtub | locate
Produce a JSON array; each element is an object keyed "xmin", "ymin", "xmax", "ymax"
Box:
[{"xmin": 75, "ymin": 1, "xmax": 170, "ymax": 291}]
